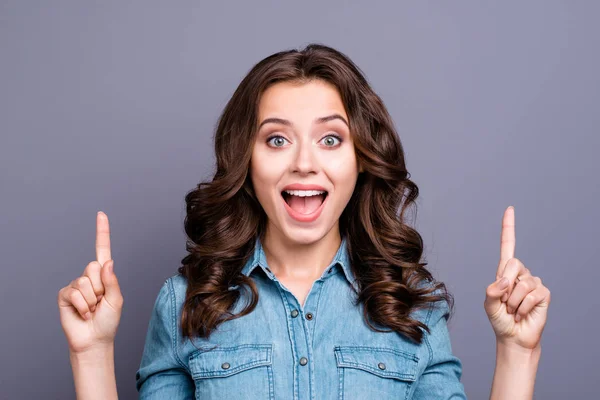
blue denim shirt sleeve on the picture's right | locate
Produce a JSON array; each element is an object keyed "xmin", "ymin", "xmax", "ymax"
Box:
[{"xmin": 413, "ymin": 301, "xmax": 467, "ymax": 400}]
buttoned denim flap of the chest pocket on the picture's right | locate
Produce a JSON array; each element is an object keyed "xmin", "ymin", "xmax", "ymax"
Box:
[{"xmin": 334, "ymin": 346, "xmax": 419, "ymax": 382}]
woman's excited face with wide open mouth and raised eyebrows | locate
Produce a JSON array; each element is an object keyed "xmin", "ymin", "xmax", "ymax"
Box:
[{"xmin": 250, "ymin": 80, "xmax": 359, "ymax": 244}]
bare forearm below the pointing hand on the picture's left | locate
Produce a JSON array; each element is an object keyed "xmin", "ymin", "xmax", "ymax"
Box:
[{"xmin": 70, "ymin": 345, "xmax": 118, "ymax": 400}]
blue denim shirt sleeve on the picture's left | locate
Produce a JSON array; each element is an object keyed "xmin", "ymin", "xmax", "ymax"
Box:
[{"xmin": 135, "ymin": 278, "xmax": 195, "ymax": 400}]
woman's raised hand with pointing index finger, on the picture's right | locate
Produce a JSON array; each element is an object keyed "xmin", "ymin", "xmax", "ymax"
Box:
[{"xmin": 484, "ymin": 206, "xmax": 550, "ymax": 349}]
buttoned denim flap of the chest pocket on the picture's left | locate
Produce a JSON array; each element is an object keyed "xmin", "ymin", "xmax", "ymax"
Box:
[{"xmin": 189, "ymin": 344, "xmax": 272, "ymax": 379}]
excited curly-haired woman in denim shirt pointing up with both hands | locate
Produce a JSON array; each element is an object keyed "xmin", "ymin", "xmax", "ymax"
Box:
[{"xmin": 58, "ymin": 44, "xmax": 550, "ymax": 400}]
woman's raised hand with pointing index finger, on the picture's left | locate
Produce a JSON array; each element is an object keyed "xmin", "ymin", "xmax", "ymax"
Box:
[{"xmin": 58, "ymin": 212, "xmax": 123, "ymax": 353}]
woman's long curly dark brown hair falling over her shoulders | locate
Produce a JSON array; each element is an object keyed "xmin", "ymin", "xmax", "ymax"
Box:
[{"xmin": 178, "ymin": 43, "xmax": 454, "ymax": 343}]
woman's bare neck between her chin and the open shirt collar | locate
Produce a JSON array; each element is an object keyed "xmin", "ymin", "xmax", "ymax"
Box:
[{"xmin": 262, "ymin": 225, "xmax": 342, "ymax": 280}]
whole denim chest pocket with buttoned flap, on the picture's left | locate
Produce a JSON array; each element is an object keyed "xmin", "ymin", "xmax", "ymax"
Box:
[{"xmin": 189, "ymin": 344, "xmax": 275, "ymax": 400}]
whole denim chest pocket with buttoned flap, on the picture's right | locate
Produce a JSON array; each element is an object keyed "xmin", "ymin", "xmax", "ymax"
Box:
[{"xmin": 334, "ymin": 346, "xmax": 419, "ymax": 400}]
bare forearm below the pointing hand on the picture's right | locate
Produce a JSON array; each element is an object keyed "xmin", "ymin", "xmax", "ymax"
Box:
[{"xmin": 490, "ymin": 343, "xmax": 542, "ymax": 400}]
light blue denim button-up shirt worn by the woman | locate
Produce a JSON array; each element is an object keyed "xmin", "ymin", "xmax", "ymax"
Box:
[{"xmin": 136, "ymin": 239, "xmax": 466, "ymax": 400}]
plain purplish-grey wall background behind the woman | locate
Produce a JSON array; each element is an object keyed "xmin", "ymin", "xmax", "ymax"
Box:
[{"xmin": 0, "ymin": 1, "xmax": 600, "ymax": 399}]
